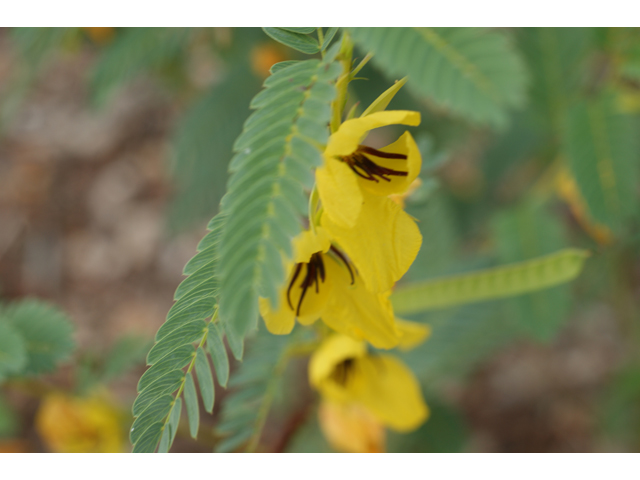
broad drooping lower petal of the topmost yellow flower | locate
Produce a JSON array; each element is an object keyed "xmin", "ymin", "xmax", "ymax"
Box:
[{"xmin": 321, "ymin": 192, "xmax": 422, "ymax": 292}]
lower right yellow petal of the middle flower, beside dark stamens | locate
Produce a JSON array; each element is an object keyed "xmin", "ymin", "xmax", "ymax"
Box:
[{"xmin": 322, "ymin": 255, "xmax": 400, "ymax": 349}]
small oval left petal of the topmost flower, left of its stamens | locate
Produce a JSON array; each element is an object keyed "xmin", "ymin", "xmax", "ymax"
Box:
[{"xmin": 316, "ymin": 159, "xmax": 362, "ymax": 228}]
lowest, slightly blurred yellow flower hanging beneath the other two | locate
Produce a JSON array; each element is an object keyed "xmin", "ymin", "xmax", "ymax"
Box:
[{"xmin": 309, "ymin": 328, "xmax": 429, "ymax": 432}]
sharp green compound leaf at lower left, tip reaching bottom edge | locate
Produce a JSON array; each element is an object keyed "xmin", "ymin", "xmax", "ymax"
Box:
[{"xmin": 130, "ymin": 215, "xmax": 231, "ymax": 452}]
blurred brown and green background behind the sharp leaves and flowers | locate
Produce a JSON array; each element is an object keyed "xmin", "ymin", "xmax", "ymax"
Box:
[{"xmin": 0, "ymin": 28, "xmax": 640, "ymax": 452}]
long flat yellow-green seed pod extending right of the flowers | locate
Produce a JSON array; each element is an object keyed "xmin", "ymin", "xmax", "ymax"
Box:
[{"xmin": 391, "ymin": 248, "xmax": 589, "ymax": 315}]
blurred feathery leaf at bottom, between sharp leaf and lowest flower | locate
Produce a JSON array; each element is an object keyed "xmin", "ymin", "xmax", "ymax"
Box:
[{"xmin": 216, "ymin": 329, "xmax": 297, "ymax": 452}]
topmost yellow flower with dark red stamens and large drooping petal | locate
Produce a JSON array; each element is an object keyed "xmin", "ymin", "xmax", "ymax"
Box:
[{"xmin": 316, "ymin": 110, "xmax": 422, "ymax": 292}]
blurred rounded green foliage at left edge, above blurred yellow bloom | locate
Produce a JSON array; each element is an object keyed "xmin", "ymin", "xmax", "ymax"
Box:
[{"xmin": 0, "ymin": 299, "xmax": 75, "ymax": 381}]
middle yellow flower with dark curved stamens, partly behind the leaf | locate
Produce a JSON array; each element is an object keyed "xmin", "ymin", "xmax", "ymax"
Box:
[{"xmin": 259, "ymin": 227, "xmax": 401, "ymax": 348}]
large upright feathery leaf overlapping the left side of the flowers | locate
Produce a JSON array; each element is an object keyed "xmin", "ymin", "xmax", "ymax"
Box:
[{"xmin": 219, "ymin": 60, "xmax": 341, "ymax": 340}]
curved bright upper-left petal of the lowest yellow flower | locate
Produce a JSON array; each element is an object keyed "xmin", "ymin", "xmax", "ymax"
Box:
[{"xmin": 309, "ymin": 335, "xmax": 367, "ymax": 388}]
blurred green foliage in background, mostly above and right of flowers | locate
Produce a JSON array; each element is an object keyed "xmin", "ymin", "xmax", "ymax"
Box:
[{"xmin": 5, "ymin": 27, "xmax": 640, "ymax": 451}]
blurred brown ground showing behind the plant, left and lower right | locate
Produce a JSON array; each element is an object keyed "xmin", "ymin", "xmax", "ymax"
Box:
[{"xmin": 0, "ymin": 31, "xmax": 632, "ymax": 452}]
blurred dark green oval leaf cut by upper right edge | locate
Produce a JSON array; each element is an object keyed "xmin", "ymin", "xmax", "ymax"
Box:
[{"xmin": 563, "ymin": 95, "xmax": 640, "ymax": 233}]
